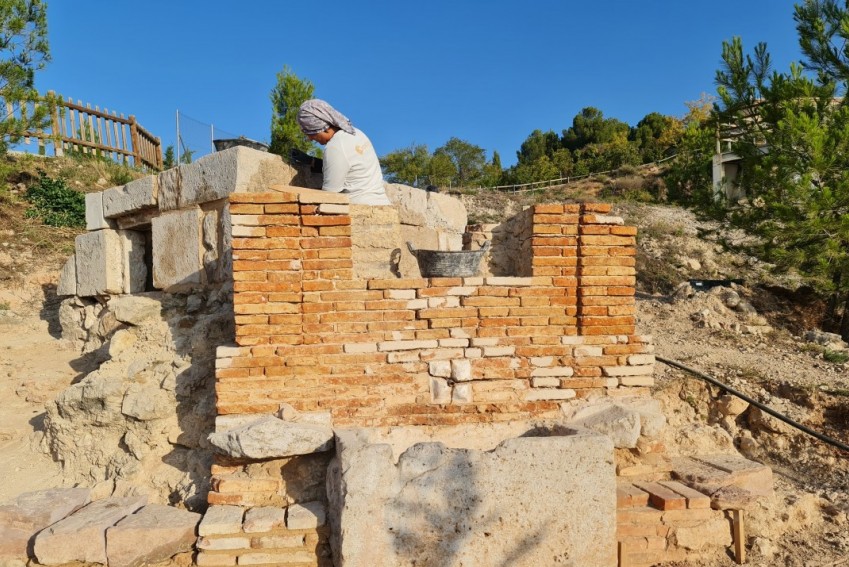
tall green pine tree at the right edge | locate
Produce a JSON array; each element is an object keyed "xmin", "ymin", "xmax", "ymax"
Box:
[{"xmin": 716, "ymin": 0, "xmax": 849, "ymax": 339}]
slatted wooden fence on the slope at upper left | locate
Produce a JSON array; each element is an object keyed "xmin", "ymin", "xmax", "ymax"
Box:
[{"xmin": 6, "ymin": 92, "xmax": 162, "ymax": 170}]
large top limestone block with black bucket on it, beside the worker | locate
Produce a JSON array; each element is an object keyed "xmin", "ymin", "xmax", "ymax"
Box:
[{"xmin": 159, "ymin": 146, "xmax": 298, "ymax": 211}]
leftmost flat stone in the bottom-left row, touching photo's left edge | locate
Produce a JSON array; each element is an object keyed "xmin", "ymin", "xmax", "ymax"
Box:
[{"xmin": 0, "ymin": 488, "xmax": 91, "ymax": 535}]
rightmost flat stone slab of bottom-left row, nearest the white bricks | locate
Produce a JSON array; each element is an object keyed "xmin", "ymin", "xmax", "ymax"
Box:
[{"xmin": 106, "ymin": 504, "xmax": 201, "ymax": 567}]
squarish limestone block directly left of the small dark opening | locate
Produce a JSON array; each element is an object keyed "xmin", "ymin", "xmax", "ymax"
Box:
[{"xmin": 74, "ymin": 230, "xmax": 147, "ymax": 297}]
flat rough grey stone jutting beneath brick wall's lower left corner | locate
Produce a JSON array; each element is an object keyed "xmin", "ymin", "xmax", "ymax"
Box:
[{"xmin": 209, "ymin": 416, "xmax": 333, "ymax": 459}]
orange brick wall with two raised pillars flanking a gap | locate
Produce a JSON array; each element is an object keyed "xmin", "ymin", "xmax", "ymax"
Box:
[{"xmin": 216, "ymin": 188, "xmax": 654, "ymax": 426}]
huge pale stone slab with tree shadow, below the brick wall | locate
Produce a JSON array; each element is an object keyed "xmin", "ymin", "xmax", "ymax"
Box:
[{"xmin": 327, "ymin": 431, "xmax": 616, "ymax": 567}]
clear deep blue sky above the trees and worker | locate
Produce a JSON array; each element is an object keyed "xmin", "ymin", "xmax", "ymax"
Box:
[{"xmin": 36, "ymin": 0, "xmax": 800, "ymax": 166}]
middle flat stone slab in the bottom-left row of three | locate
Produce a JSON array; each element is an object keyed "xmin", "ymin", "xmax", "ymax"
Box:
[{"xmin": 34, "ymin": 496, "xmax": 147, "ymax": 565}]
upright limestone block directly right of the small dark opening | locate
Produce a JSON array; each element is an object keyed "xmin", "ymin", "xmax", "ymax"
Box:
[{"xmin": 151, "ymin": 207, "xmax": 203, "ymax": 291}]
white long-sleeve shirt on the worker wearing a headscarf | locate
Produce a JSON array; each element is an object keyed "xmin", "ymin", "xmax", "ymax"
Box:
[{"xmin": 322, "ymin": 128, "xmax": 391, "ymax": 205}]
